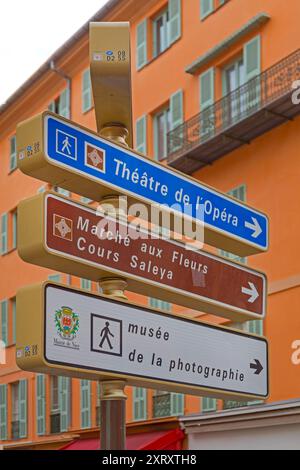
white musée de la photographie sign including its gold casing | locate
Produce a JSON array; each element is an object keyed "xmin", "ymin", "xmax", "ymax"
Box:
[{"xmin": 17, "ymin": 282, "xmax": 269, "ymax": 400}]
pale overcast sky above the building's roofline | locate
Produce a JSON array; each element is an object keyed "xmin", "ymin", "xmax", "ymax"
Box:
[{"xmin": 0, "ymin": 0, "xmax": 107, "ymax": 104}]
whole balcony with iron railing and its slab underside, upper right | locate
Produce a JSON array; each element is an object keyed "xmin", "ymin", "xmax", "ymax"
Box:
[{"xmin": 167, "ymin": 49, "xmax": 300, "ymax": 173}]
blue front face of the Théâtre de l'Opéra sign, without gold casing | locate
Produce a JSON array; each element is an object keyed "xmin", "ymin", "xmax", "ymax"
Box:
[{"xmin": 44, "ymin": 115, "xmax": 268, "ymax": 251}]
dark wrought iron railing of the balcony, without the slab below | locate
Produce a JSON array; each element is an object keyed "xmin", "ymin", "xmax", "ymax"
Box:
[{"xmin": 167, "ymin": 49, "xmax": 300, "ymax": 163}]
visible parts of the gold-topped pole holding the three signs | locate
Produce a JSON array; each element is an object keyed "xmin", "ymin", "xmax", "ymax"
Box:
[{"xmin": 90, "ymin": 23, "xmax": 132, "ymax": 450}]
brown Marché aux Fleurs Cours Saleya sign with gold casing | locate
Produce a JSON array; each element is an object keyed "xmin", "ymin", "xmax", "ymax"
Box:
[{"xmin": 18, "ymin": 192, "xmax": 267, "ymax": 321}]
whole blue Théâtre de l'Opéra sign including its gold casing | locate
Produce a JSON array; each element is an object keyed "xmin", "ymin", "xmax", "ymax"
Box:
[{"xmin": 17, "ymin": 112, "xmax": 268, "ymax": 256}]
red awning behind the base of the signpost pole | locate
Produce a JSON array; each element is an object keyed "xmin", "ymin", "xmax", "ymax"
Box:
[{"xmin": 61, "ymin": 429, "xmax": 184, "ymax": 450}]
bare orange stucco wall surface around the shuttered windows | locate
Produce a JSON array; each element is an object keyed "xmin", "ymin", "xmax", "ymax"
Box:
[{"xmin": 0, "ymin": 0, "xmax": 300, "ymax": 448}]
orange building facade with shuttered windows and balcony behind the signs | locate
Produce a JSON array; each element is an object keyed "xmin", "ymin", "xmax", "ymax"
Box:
[{"xmin": 0, "ymin": 0, "xmax": 300, "ymax": 449}]
